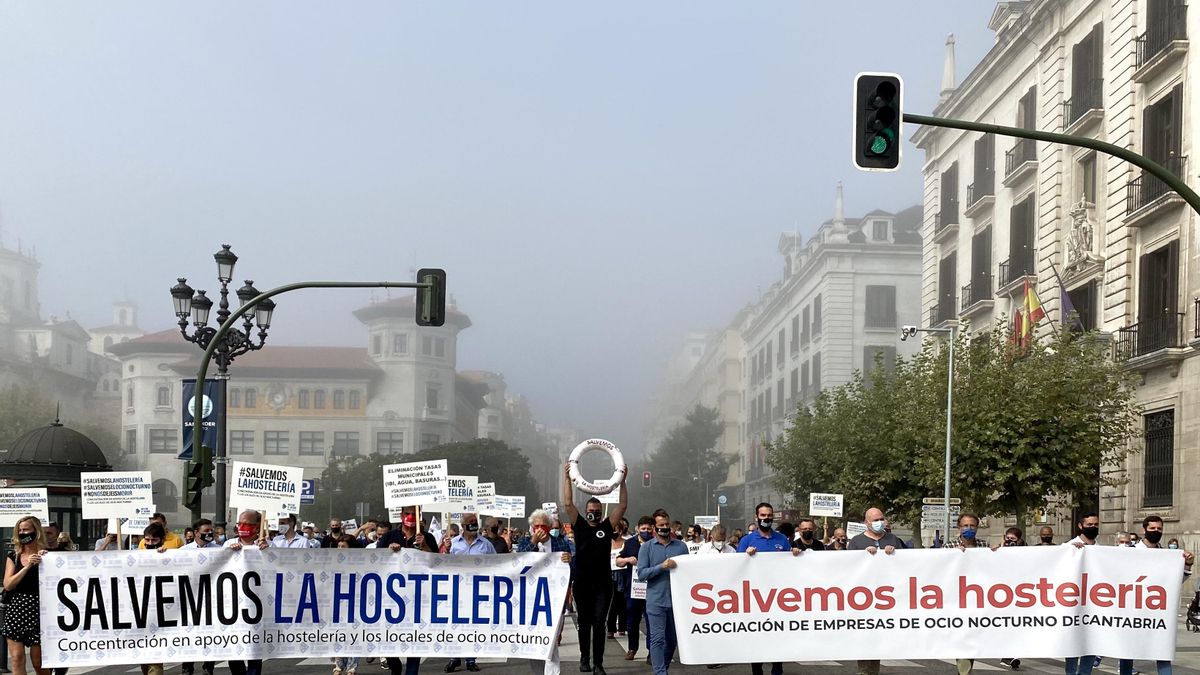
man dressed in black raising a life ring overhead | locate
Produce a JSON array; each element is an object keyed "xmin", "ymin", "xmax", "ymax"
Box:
[{"xmin": 563, "ymin": 461, "xmax": 629, "ymax": 675}]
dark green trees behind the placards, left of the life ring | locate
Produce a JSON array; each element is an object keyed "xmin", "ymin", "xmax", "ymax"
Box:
[{"xmin": 301, "ymin": 438, "xmax": 541, "ymax": 524}]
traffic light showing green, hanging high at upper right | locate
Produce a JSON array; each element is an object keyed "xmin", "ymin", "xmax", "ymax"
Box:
[{"xmin": 854, "ymin": 72, "xmax": 904, "ymax": 171}]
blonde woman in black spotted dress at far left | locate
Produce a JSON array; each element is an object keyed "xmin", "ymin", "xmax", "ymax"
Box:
[{"xmin": 4, "ymin": 515, "xmax": 49, "ymax": 675}]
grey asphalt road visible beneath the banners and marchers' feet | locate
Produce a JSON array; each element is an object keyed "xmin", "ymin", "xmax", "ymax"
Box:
[{"xmin": 29, "ymin": 615, "xmax": 1200, "ymax": 675}]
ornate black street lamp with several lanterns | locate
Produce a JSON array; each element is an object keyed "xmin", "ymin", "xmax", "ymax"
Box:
[{"xmin": 170, "ymin": 244, "xmax": 275, "ymax": 526}]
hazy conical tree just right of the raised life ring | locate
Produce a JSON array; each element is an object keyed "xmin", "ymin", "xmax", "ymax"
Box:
[{"xmin": 629, "ymin": 406, "xmax": 733, "ymax": 524}]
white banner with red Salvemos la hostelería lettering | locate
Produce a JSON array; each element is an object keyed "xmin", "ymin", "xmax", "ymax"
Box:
[{"xmin": 671, "ymin": 546, "xmax": 1183, "ymax": 664}]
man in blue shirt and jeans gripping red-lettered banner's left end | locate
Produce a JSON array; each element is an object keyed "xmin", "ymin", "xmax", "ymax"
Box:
[{"xmin": 637, "ymin": 509, "xmax": 688, "ymax": 675}]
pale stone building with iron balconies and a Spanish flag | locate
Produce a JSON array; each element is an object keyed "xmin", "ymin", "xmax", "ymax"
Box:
[{"xmin": 913, "ymin": 0, "xmax": 1200, "ymax": 533}]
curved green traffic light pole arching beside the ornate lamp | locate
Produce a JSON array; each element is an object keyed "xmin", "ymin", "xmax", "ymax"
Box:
[{"xmin": 192, "ymin": 276, "xmax": 444, "ymax": 525}]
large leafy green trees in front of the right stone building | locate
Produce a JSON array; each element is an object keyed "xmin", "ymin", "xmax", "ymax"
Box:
[{"xmin": 768, "ymin": 323, "xmax": 1138, "ymax": 525}]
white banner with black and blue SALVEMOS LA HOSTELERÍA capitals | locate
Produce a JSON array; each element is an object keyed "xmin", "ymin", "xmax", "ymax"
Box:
[{"xmin": 38, "ymin": 549, "xmax": 570, "ymax": 668}]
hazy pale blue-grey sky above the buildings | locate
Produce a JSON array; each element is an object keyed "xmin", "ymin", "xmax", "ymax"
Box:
[{"xmin": 0, "ymin": 0, "xmax": 994, "ymax": 449}]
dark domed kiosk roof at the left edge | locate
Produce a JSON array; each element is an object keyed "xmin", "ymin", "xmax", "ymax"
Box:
[{"xmin": 0, "ymin": 419, "xmax": 112, "ymax": 478}]
